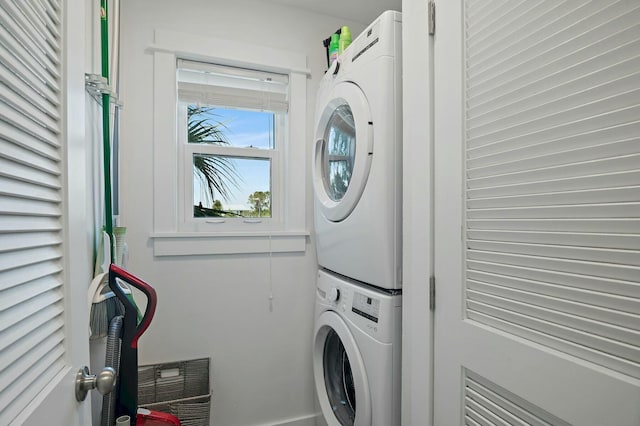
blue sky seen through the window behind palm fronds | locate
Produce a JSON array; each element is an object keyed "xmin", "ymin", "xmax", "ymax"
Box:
[{"xmin": 193, "ymin": 109, "xmax": 273, "ymax": 206}]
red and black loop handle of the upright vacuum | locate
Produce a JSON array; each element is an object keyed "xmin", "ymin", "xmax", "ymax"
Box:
[{"xmin": 109, "ymin": 264, "xmax": 158, "ymax": 348}]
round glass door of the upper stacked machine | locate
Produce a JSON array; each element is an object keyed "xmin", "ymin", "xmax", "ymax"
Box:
[{"xmin": 312, "ymin": 82, "xmax": 373, "ymax": 222}]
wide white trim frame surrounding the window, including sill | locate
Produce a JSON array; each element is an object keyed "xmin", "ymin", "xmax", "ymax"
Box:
[{"xmin": 148, "ymin": 29, "xmax": 310, "ymax": 256}]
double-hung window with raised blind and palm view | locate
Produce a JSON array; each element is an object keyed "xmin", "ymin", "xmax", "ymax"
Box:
[{"xmin": 177, "ymin": 60, "xmax": 289, "ymax": 226}]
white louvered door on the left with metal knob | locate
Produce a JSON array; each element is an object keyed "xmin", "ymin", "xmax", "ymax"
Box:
[{"xmin": 0, "ymin": 0, "xmax": 92, "ymax": 426}]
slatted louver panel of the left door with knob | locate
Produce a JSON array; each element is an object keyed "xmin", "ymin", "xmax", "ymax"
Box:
[{"xmin": 0, "ymin": 0, "xmax": 65, "ymax": 425}]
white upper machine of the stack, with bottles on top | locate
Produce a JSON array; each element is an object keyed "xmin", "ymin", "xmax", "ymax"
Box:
[{"xmin": 312, "ymin": 11, "xmax": 402, "ymax": 289}]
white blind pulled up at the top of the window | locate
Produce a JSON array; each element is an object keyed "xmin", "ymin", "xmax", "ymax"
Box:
[{"xmin": 178, "ymin": 59, "xmax": 289, "ymax": 112}]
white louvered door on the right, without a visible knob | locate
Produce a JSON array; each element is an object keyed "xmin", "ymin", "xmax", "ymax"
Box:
[{"xmin": 434, "ymin": 0, "xmax": 640, "ymax": 426}]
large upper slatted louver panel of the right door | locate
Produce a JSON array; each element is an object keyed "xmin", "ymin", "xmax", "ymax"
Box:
[{"xmin": 465, "ymin": 1, "xmax": 640, "ymax": 378}]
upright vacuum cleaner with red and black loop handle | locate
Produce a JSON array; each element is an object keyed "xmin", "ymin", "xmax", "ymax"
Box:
[{"xmin": 109, "ymin": 264, "xmax": 180, "ymax": 426}]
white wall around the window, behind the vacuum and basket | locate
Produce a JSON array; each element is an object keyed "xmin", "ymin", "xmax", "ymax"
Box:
[{"xmin": 120, "ymin": 0, "xmax": 364, "ymax": 426}]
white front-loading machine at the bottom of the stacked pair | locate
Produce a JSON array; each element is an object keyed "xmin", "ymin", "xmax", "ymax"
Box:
[{"xmin": 313, "ymin": 271, "xmax": 402, "ymax": 426}]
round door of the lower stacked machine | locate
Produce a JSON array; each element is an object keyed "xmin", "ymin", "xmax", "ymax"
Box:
[{"xmin": 313, "ymin": 311, "xmax": 371, "ymax": 426}]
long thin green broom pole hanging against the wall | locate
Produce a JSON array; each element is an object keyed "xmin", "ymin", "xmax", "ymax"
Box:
[{"xmin": 100, "ymin": 0, "xmax": 115, "ymax": 263}]
